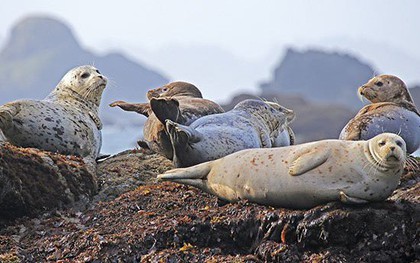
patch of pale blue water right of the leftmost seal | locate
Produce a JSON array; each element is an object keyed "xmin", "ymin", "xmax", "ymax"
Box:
[{"xmin": 101, "ymin": 126, "xmax": 143, "ymax": 154}]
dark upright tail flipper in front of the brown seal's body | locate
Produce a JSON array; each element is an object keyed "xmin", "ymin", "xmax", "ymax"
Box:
[{"xmin": 150, "ymin": 98, "xmax": 183, "ymax": 125}]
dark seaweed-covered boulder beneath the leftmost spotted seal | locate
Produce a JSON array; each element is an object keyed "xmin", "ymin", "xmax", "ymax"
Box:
[{"xmin": 0, "ymin": 143, "xmax": 97, "ymax": 224}]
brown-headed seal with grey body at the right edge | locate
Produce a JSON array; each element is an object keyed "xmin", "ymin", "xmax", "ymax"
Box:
[{"xmin": 339, "ymin": 75, "xmax": 420, "ymax": 153}]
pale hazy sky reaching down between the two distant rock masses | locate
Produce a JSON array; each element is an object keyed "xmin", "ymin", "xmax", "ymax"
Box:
[{"xmin": 0, "ymin": 0, "xmax": 420, "ymax": 101}]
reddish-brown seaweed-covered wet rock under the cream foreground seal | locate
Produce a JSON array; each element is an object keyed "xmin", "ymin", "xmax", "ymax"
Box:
[{"xmin": 0, "ymin": 150, "xmax": 420, "ymax": 262}]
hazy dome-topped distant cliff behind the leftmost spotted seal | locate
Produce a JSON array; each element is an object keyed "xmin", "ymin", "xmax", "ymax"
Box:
[{"xmin": 0, "ymin": 16, "xmax": 168, "ymax": 127}]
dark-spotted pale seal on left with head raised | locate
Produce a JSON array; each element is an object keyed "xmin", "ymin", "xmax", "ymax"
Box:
[{"xmin": 0, "ymin": 65, "xmax": 107, "ymax": 160}]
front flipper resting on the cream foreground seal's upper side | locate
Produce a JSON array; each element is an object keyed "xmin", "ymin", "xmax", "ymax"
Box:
[{"xmin": 289, "ymin": 150, "xmax": 330, "ymax": 175}]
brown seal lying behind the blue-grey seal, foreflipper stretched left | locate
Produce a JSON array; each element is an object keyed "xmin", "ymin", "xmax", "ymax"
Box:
[{"xmin": 110, "ymin": 81, "xmax": 224, "ymax": 160}]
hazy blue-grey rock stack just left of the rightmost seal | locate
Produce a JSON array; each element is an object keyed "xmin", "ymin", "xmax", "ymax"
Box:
[{"xmin": 261, "ymin": 49, "xmax": 378, "ymax": 110}]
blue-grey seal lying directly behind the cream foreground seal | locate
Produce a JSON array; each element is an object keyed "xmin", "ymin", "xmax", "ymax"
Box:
[{"xmin": 166, "ymin": 99, "xmax": 295, "ymax": 167}]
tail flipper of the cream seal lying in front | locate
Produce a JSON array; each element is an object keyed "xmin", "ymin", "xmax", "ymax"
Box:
[{"xmin": 157, "ymin": 161, "xmax": 213, "ymax": 189}]
